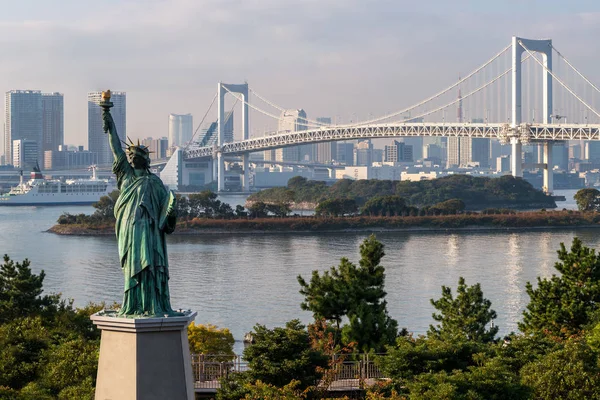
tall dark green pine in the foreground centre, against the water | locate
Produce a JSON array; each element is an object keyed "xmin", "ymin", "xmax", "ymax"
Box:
[{"xmin": 298, "ymin": 235, "xmax": 398, "ymax": 351}]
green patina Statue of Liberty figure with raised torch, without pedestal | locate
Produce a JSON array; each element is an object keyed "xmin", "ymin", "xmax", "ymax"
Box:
[{"xmin": 100, "ymin": 90, "xmax": 183, "ymax": 318}]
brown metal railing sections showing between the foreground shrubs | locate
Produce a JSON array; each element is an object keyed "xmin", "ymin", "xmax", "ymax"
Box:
[{"xmin": 192, "ymin": 354, "xmax": 386, "ymax": 392}]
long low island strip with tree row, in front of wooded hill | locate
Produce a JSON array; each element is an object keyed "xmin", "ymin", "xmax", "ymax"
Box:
[{"xmin": 49, "ymin": 183, "xmax": 600, "ymax": 235}]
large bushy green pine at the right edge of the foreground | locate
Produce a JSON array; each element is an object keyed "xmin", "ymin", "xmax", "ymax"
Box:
[{"xmin": 519, "ymin": 238, "xmax": 600, "ymax": 338}]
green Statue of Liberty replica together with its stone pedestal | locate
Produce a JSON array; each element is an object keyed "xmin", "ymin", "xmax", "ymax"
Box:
[{"xmin": 90, "ymin": 90, "xmax": 197, "ymax": 400}]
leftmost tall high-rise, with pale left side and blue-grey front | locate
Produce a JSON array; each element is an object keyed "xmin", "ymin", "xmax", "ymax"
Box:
[{"xmin": 4, "ymin": 90, "xmax": 44, "ymax": 164}]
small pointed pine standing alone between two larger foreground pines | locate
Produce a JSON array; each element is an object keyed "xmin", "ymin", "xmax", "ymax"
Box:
[{"xmin": 428, "ymin": 276, "xmax": 498, "ymax": 342}]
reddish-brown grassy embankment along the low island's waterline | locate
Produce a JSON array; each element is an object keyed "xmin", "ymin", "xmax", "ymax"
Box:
[{"xmin": 49, "ymin": 211, "xmax": 600, "ymax": 235}]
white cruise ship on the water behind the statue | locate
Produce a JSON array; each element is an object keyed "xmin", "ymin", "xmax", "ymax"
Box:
[{"xmin": 0, "ymin": 165, "xmax": 116, "ymax": 206}]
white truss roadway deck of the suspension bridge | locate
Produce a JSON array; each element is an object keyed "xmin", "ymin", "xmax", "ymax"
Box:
[{"xmin": 184, "ymin": 123, "xmax": 600, "ymax": 159}]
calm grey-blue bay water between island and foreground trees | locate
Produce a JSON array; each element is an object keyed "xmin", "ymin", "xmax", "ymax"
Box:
[{"xmin": 0, "ymin": 191, "xmax": 600, "ymax": 350}]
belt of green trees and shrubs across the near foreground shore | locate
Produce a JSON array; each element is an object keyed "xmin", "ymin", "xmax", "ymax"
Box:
[{"xmin": 5, "ymin": 236, "xmax": 600, "ymax": 400}]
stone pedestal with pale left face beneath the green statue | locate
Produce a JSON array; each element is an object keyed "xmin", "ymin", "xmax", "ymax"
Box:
[{"xmin": 91, "ymin": 311, "xmax": 197, "ymax": 400}]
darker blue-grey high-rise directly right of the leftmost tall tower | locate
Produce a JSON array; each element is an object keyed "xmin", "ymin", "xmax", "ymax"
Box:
[{"xmin": 42, "ymin": 92, "xmax": 65, "ymax": 156}]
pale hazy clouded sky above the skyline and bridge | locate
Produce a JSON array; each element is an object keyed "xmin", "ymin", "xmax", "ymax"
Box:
[{"xmin": 0, "ymin": 0, "xmax": 600, "ymax": 150}]
